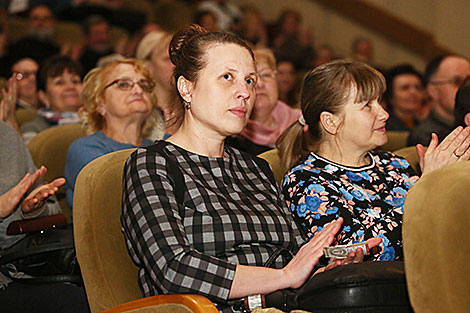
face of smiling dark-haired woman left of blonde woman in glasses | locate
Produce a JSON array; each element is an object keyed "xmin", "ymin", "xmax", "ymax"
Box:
[{"xmin": 40, "ymin": 69, "xmax": 82, "ymax": 112}]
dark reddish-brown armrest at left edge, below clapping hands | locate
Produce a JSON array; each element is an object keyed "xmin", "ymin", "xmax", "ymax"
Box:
[{"xmin": 7, "ymin": 213, "xmax": 67, "ymax": 235}]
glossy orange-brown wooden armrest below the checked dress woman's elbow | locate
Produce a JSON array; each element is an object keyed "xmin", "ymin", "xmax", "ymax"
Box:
[{"xmin": 101, "ymin": 294, "xmax": 219, "ymax": 313}]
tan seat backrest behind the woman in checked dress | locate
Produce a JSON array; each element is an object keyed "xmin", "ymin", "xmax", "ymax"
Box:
[{"xmin": 73, "ymin": 149, "xmax": 138, "ymax": 312}]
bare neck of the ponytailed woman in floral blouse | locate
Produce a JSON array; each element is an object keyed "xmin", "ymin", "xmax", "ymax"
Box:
[{"xmin": 314, "ymin": 141, "xmax": 371, "ymax": 167}]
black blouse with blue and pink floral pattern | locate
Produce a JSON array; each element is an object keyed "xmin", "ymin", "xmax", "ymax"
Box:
[{"xmin": 282, "ymin": 152, "xmax": 418, "ymax": 261}]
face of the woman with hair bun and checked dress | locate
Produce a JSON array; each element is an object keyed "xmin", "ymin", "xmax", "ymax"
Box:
[{"xmin": 178, "ymin": 44, "xmax": 256, "ymax": 138}]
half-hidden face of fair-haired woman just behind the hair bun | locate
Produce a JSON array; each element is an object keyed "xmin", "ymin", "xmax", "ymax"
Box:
[{"xmin": 150, "ymin": 43, "xmax": 175, "ymax": 90}]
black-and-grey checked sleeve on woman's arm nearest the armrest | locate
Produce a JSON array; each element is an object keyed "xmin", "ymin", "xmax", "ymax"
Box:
[{"xmin": 122, "ymin": 149, "xmax": 236, "ymax": 302}]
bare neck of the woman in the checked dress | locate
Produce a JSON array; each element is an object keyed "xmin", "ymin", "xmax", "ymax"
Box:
[{"xmin": 167, "ymin": 119, "xmax": 225, "ymax": 157}]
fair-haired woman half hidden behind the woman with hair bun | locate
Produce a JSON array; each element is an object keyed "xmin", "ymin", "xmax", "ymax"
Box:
[{"xmin": 136, "ymin": 31, "xmax": 180, "ymax": 139}]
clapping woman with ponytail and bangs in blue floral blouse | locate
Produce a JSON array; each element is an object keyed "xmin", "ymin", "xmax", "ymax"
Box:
[{"xmin": 278, "ymin": 60, "xmax": 470, "ymax": 261}]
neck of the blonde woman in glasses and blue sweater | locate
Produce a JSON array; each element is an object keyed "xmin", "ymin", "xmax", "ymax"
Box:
[{"xmin": 102, "ymin": 122, "xmax": 142, "ymax": 146}]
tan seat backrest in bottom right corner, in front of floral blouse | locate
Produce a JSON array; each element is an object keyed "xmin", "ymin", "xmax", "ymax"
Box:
[{"xmin": 403, "ymin": 162, "xmax": 470, "ymax": 313}]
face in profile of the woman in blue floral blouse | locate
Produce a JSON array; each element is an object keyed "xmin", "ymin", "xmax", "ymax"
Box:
[{"xmin": 337, "ymin": 94, "xmax": 389, "ymax": 153}]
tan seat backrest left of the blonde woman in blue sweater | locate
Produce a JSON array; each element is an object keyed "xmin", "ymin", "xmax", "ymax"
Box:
[{"xmin": 28, "ymin": 124, "xmax": 85, "ymax": 220}]
